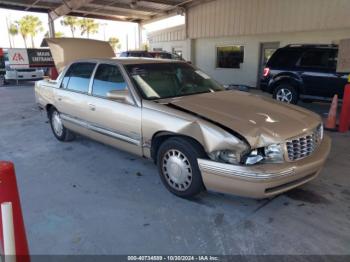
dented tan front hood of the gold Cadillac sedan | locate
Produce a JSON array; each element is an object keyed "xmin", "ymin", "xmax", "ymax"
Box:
[{"xmin": 171, "ymin": 91, "xmax": 320, "ymax": 148}]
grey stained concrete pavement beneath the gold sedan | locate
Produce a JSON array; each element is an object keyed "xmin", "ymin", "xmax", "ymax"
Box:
[{"xmin": 0, "ymin": 85, "xmax": 350, "ymax": 255}]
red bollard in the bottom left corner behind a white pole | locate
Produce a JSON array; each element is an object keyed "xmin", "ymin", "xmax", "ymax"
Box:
[{"xmin": 0, "ymin": 161, "xmax": 30, "ymax": 262}]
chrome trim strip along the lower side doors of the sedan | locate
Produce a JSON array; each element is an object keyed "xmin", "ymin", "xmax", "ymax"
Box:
[{"xmin": 61, "ymin": 113, "xmax": 141, "ymax": 146}]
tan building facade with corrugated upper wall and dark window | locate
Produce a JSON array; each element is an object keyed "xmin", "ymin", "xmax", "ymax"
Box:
[{"xmin": 149, "ymin": 0, "xmax": 350, "ymax": 87}]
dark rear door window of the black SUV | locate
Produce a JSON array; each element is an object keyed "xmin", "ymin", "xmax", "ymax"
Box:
[{"xmin": 300, "ymin": 50, "xmax": 331, "ymax": 69}]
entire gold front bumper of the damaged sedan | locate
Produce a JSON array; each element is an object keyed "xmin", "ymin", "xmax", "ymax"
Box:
[{"xmin": 198, "ymin": 136, "xmax": 331, "ymax": 198}]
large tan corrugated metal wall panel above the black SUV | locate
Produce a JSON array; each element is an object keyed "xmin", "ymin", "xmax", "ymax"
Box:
[{"xmin": 188, "ymin": 0, "xmax": 350, "ymax": 38}]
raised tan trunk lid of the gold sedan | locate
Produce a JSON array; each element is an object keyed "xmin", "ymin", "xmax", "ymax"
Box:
[{"xmin": 44, "ymin": 38, "xmax": 115, "ymax": 72}]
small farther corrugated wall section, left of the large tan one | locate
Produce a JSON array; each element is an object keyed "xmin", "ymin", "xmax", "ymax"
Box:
[{"xmin": 148, "ymin": 26, "xmax": 186, "ymax": 44}]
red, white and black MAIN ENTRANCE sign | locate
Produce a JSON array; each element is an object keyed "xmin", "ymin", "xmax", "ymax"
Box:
[{"xmin": 8, "ymin": 48, "xmax": 55, "ymax": 69}]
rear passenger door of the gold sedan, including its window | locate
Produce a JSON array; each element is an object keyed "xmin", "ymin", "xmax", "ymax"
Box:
[{"xmin": 55, "ymin": 62, "xmax": 96, "ymax": 135}]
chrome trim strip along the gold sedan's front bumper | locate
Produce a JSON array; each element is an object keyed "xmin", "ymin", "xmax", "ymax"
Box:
[{"xmin": 198, "ymin": 159, "xmax": 295, "ymax": 180}]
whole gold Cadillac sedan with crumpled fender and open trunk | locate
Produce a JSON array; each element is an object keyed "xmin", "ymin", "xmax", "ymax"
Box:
[{"xmin": 35, "ymin": 38, "xmax": 331, "ymax": 198}]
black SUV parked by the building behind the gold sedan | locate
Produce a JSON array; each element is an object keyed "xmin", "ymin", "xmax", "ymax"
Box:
[{"xmin": 260, "ymin": 45, "xmax": 348, "ymax": 104}]
